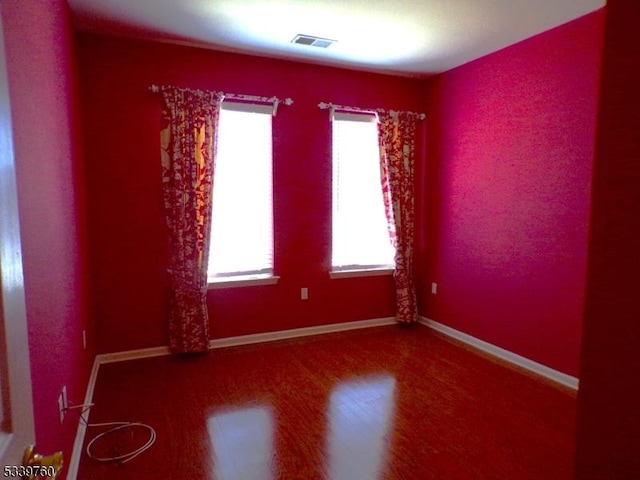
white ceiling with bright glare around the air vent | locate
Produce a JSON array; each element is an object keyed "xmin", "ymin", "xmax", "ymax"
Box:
[{"xmin": 69, "ymin": 0, "xmax": 605, "ymax": 76}]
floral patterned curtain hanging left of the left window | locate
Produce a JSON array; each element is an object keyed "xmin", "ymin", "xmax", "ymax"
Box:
[{"xmin": 160, "ymin": 87, "xmax": 222, "ymax": 352}]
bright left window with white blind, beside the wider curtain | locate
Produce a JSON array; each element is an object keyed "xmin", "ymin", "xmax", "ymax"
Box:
[{"xmin": 208, "ymin": 101, "xmax": 276, "ymax": 285}]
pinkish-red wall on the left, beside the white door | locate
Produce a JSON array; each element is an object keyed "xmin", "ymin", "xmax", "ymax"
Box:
[{"xmin": 2, "ymin": 0, "xmax": 93, "ymax": 468}]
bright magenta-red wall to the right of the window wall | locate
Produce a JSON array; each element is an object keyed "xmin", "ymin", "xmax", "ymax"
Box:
[{"xmin": 420, "ymin": 11, "xmax": 604, "ymax": 375}]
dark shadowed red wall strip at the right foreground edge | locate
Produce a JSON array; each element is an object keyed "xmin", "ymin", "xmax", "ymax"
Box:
[{"xmin": 576, "ymin": 0, "xmax": 640, "ymax": 480}]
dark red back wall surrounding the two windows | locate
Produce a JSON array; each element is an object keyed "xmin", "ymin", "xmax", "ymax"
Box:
[{"xmin": 78, "ymin": 34, "xmax": 421, "ymax": 352}]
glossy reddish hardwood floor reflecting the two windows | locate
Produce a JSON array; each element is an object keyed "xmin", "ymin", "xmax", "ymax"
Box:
[{"xmin": 78, "ymin": 326, "xmax": 576, "ymax": 480}]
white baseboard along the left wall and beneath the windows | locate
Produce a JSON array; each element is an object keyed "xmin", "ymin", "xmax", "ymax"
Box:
[{"xmin": 67, "ymin": 317, "xmax": 395, "ymax": 480}]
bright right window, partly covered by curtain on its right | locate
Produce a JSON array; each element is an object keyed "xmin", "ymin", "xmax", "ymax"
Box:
[{"xmin": 331, "ymin": 112, "xmax": 395, "ymax": 272}]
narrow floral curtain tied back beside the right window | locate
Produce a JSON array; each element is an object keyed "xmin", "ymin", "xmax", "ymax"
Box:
[{"xmin": 378, "ymin": 112, "xmax": 418, "ymax": 323}]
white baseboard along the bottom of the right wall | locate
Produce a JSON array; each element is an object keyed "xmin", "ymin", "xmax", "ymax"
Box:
[{"xmin": 420, "ymin": 317, "xmax": 579, "ymax": 390}]
